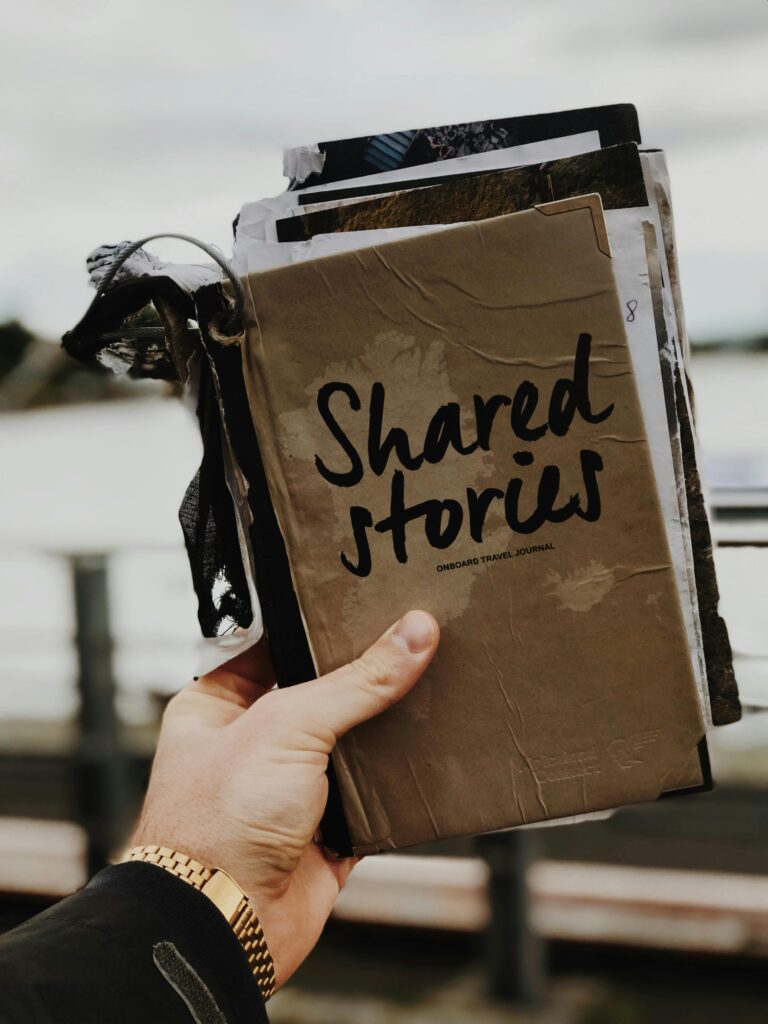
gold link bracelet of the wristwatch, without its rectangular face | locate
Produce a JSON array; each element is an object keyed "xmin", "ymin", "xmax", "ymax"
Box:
[{"xmin": 123, "ymin": 846, "xmax": 276, "ymax": 1000}]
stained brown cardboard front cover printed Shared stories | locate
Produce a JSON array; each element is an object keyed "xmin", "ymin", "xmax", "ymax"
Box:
[{"xmin": 244, "ymin": 203, "xmax": 706, "ymax": 853}]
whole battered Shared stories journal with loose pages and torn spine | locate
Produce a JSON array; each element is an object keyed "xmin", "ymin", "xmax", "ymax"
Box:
[{"xmin": 67, "ymin": 104, "xmax": 739, "ymax": 854}]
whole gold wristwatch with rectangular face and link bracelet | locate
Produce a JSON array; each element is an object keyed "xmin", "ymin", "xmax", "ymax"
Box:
[{"xmin": 123, "ymin": 846, "xmax": 275, "ymax": 999}]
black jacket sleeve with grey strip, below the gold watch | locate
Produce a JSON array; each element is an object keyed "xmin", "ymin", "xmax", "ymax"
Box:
[{"xmin": 0, "ymin": 863, "xmax": 267, "ymax": 1024}]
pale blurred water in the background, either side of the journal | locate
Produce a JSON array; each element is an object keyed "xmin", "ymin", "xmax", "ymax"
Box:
[{"xmin": 0, "ymin": 353, "xmax": 768, "ymax": 719}]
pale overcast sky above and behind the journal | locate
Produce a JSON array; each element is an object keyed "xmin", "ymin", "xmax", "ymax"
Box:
[{"xmin": 0, "ymin": 0, "xmax": 768, "ymax": 339}]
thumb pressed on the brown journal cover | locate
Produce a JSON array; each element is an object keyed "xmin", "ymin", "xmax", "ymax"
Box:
[{"xmin": 290, "ymin": 611, "xmax": 440, "ymax": 739}]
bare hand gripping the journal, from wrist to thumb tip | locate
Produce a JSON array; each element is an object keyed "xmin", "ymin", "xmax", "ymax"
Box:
[{"xmin": 132, "ymin": 611, "xmax": 439, "ymax": 985}]
